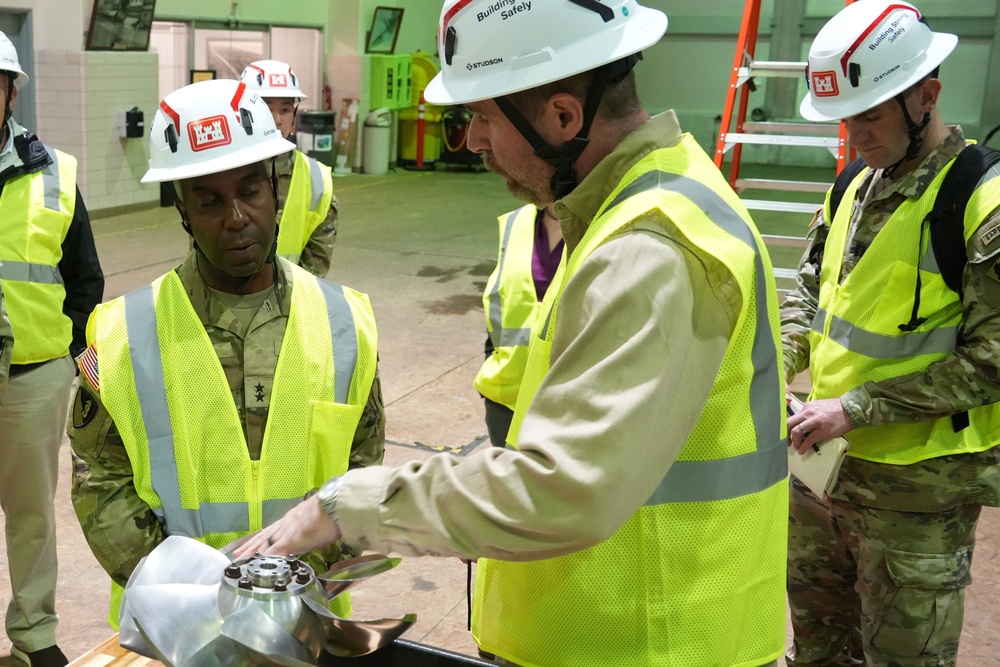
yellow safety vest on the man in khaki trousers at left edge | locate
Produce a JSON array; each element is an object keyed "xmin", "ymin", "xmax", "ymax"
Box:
[{"xmin": 0, "ymin": 146, "xmax": 76, "ymax": 364}]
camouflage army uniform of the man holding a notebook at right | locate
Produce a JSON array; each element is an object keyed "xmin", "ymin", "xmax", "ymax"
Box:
[{"xmin": 781, "ymin": 128, "xmax": 1000, "ymax": 667}]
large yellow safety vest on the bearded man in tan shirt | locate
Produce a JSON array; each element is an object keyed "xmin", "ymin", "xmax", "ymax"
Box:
[{"xmin": 472, "ymin": 135, "xmax": 788, "ymax": 667}]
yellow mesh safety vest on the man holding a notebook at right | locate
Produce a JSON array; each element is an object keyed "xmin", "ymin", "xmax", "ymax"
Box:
[{"xmin": 809, "ymin": 157, "xmax": 1000, "ymax": 465}]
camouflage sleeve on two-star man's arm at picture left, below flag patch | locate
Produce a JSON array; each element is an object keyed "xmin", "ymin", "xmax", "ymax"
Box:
[{"xmin": 66, "ymin": 375, "xmax": 166, "ymax": 586}]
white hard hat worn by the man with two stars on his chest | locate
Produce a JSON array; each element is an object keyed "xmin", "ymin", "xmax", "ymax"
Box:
[{"xmin": 142, "ymin": 79, "xmax": 295, "ymax": 183}]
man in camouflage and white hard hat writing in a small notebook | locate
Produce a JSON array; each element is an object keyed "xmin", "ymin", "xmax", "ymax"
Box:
[{"xmin": 782, "ymin": 0, "xmax": 1000, "ymax": 667}]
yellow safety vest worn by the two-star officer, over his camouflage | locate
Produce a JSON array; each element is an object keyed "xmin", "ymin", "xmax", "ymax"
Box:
[{"xmin": 87, "ymin": 262, "xmax": 378, "ymax": 627}]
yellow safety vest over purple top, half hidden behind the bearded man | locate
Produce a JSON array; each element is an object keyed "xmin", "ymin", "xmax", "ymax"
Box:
[{"xmin": 475, "ymin": 206, "xmax": 565, "ymax": 410}]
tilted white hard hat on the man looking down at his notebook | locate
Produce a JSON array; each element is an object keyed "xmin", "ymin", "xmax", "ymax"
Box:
[{"xmin": 799, "ymin": 0, "xmax": 958, "ymax": 121}]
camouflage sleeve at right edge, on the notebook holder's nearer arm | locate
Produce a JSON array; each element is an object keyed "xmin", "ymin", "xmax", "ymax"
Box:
[{"xmin": 841, "ymin": 207, "xmax": 1000, "ymax": 427}]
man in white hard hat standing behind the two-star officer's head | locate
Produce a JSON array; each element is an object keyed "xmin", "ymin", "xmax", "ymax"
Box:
[{"xmin": 240, "ymin": 60, "xmax": 340, "ymax": 278}]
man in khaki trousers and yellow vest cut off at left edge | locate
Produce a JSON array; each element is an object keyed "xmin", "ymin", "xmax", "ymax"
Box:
[{"xmin": 0, "ymin": 28, "xmax": 104, "ymax": 667}]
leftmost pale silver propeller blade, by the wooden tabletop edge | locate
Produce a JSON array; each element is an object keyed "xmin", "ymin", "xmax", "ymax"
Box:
[{"xmin": 126, "ymin": 584, "xmax": 222, "ymax": 667}]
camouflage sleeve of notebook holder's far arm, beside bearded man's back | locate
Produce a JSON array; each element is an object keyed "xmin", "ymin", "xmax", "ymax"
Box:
[{"xmin": 781, "ymin": 208, "xmax": 830, "ymax": 382}]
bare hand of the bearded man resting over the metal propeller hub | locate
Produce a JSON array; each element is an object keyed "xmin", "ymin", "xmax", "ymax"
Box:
[{"xmin": 232, "ymin": 496, "xmax": 340, "ymax": 560}]
